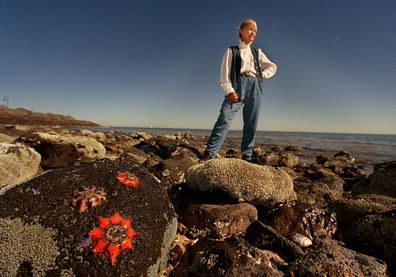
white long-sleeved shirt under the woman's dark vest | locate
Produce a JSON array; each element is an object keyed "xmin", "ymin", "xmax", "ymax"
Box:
[{"xmin": 220, "ymin": 41, "xmax": 277, "ymax": 94}]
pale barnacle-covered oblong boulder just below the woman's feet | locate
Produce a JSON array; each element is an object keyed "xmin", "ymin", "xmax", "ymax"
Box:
[{"xmin": 187, "ymin": 159, "xmax": 296, "ymax": 206}]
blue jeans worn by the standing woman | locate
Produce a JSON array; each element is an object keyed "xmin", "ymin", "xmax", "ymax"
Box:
[{"xmin": 206, "ymin": 77, "xmax": 262, "ymax": 160}]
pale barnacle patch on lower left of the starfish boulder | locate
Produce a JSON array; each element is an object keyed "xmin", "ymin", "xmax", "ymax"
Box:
[{"xmin": 0, "ymin": 218, "xmax": 60, "ymax": 277}]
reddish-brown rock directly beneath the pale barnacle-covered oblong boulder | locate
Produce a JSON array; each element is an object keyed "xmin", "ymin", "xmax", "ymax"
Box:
[{"xmin": 180, "ymin": 203, "xmax": 257, "ymax": 239}]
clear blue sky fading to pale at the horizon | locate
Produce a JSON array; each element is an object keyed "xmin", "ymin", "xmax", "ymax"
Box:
[{"xmin": 0, "ymin": 0, "xmax": 396, "ymax": 134}]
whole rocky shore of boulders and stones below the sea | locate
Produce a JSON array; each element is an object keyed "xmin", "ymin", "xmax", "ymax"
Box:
[{"xmin": 0, "ymin": 124, "xmax": 396, "ymax": 276}]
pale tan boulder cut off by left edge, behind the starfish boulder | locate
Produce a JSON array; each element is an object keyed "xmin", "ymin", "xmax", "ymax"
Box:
[{"xmin": 0, "ymin": 142, "xmax": 41, "ymax": 191}]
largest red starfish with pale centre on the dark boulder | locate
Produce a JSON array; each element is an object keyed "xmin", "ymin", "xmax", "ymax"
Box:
[{"xmin": 89, "ymin": 212, "xmax": 137, "ymax": 265}]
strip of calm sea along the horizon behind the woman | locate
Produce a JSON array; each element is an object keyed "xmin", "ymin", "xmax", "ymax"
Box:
[{"xmin": 89, "ymin": 127, "xmax": 396, "ymax": 163}]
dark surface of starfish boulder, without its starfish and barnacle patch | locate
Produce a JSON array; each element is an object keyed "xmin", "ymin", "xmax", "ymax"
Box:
[{"xmin": 0, "ymin": 156, "xmax": 177, "ymax": 276}]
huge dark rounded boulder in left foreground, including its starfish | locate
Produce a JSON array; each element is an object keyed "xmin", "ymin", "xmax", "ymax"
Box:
[{"xmin": 0, "ymin": 156, "xmax": 177, "ymax": 276}]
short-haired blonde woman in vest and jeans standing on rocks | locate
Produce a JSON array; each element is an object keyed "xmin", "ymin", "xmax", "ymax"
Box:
[{"xmin": 203, "ymin": 18, "xmax": 277, "ymax": 161}]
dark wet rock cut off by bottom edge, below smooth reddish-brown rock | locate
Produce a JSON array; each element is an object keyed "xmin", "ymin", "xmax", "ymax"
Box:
[{"xmin": 170, "ymin": 235, "xmax": 283, "ymax": 277}]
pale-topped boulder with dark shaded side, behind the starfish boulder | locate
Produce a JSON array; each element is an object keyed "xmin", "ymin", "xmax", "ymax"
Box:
[{"xmin": 18, "ymin": 132, "xmax": 106, "ymax": 168}]
